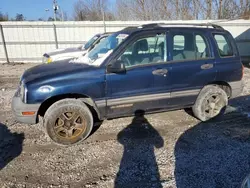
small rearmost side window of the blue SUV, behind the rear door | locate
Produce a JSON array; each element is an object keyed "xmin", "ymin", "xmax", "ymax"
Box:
[{"xmin": 214, "ymin": 34, "xmax": 234, "ymax": 57}]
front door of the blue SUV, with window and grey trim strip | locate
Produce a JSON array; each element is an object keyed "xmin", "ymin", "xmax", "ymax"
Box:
[{"xmin": 106, "ymin": 32, "xmax": 171, "ymax": 118}]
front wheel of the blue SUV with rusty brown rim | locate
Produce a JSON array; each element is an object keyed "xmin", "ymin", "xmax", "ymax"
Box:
[{"xmin": 44, "ymin": 99, "xmax": 93, "ymax": 145}]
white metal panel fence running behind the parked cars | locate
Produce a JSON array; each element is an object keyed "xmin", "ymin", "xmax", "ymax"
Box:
[{"xmin": 0, "ymin": 20, "xmax": 250, "ymax": 62}]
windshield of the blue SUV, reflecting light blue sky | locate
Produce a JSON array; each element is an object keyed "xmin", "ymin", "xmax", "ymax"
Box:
[{"xmin": 88, "ymin": 33, "xmax": 128, "ymax": 62}]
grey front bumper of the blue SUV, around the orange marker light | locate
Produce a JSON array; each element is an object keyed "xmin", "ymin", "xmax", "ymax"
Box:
[{"xmin": 11, "ymin": 96, "xmax": 41, "ymax": 124}]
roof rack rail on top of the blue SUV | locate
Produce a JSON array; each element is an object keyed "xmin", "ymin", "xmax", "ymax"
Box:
[{"xmin": 139, "ymin": 23, "xmax": 224, "ymax": 30}]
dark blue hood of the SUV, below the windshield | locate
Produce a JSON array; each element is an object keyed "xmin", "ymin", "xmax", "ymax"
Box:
[{"xmin": 21, "ymin": 61, "xmax": 98, "ymax": 83}]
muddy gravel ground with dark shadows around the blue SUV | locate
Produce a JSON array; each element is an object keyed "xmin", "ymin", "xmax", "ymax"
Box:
[{"xmin": 0, "ymin": 64, "xmax": 250, "ymax": 188}]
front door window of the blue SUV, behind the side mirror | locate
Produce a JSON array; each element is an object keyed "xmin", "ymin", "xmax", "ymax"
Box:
[{"xmin": 119, "ymin": 34, "xmax": 166, "ymax": 67}]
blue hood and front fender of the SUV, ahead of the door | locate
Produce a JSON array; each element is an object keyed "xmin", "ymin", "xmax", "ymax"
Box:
[{"xmin": 22, "ymin": 62, "xmax": 105, "ymax": 104}]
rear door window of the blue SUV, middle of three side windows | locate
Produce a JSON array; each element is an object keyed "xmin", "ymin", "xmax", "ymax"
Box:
[{"xmin": 172, "ymin": 32, "xmax": 210, "ymax": 61}]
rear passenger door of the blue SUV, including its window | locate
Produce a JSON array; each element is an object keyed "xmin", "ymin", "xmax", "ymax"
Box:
[{"xmin": 169, "ymin": 29, "xmax": 216, "ymax": 108}]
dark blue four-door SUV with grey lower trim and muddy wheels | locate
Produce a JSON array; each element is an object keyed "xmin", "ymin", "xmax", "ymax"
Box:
[{"xmin": 12, "ymin": 23, "xmax": 243, "ymax": 145}]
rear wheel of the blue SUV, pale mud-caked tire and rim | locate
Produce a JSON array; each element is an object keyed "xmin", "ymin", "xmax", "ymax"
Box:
[{"xmin": 192, "ymin": 85, "xmax": 228, "ymax": 121}]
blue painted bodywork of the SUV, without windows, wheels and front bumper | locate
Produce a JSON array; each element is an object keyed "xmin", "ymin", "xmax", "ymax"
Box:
[{"xmin": 15, "ymin": 25, "xmax": 242, "ymax": 122}]
